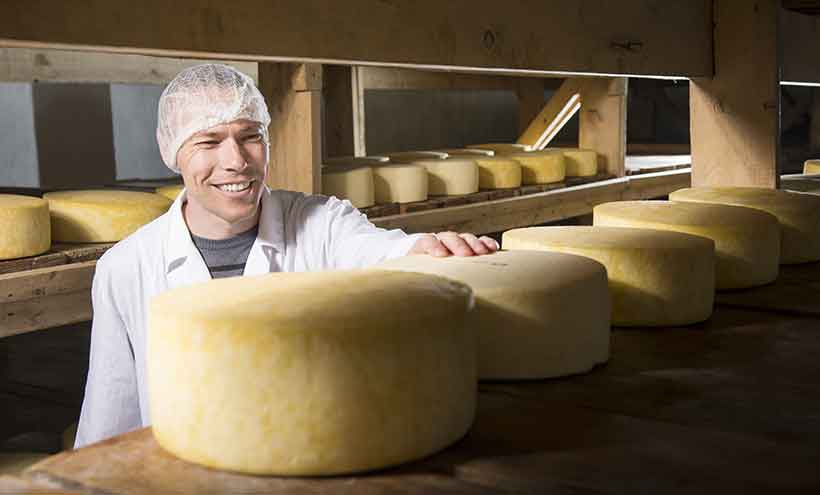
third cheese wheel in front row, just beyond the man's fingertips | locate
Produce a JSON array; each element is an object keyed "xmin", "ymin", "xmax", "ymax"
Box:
[{"xmin": 502, "ymin": 227, "xmax": 715, "ymax": 326}]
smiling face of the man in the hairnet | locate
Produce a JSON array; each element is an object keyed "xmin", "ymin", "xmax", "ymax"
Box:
[{"xmin": 177, "ymin": 120, "xmax": 269, "ymax": 224}]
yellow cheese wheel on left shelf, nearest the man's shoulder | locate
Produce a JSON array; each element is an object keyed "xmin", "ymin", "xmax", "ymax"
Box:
[{"xmin": 43, "ymin": 190, "xmax": 171, "ymax": 242}]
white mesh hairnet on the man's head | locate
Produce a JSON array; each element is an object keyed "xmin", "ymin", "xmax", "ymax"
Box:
[{"xmin": 157, "ymin": 64, "xmax": 270, "ymax": 173}]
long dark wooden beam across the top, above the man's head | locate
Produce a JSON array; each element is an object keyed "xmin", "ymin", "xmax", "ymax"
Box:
[{"xmin": 0, "ymin": 0, "xmax": 712, "ymax": 76}]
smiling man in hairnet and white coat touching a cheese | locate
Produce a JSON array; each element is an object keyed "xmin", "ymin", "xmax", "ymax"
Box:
[{"xmin": 75, "ymin": 64, "xmax": 498, "ymax": 447}]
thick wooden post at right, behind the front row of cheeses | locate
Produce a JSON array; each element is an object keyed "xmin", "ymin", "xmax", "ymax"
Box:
[{"xmin": 689, "ymin": 0, "xmax": 780, "ymax": 187}]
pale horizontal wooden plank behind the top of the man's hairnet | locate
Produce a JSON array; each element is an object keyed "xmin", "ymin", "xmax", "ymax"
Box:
[{"xmin": 0, "ymin": 48, "xmax": 258, "ymax": 84}]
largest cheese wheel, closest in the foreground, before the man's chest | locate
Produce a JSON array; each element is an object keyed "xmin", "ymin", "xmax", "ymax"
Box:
[{"xmin": 147, "ymin": 270, "xmax": 477, "ymax": 475}]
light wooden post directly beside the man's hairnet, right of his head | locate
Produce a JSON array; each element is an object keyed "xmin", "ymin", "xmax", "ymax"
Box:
[{"xmin": 259, "ymin": 62, "xmax": 322, "ymax": 193}]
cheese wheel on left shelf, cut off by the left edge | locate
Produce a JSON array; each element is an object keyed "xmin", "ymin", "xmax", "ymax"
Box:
[{"xmin": 0, "ymin": 194, "xmax": 51, "ymax": 260}]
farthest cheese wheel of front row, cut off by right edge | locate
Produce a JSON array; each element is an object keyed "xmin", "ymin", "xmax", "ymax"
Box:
[{"xmin": 669, "ymin": 187, "xmax": 820, "ymax": 264}]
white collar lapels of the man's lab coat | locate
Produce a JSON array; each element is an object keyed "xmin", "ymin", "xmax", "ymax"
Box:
[{"xmin": 165, "ymin": 186, "xmax": 285, "ymax": 289}]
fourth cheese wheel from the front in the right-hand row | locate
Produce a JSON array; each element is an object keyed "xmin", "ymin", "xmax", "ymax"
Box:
[{"xmin": 593, "ymin": 201, "xmax": 780, "ymax": 289}]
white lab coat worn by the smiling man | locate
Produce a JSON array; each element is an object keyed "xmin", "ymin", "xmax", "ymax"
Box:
[{"xmin": 75, "ymin": 188, "xmax": 418, "ymax": 447}]
